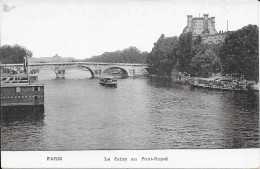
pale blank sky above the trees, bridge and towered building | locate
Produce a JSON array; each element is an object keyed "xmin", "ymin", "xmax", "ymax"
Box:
[{"xmin": 0, "ymin": 0, "xmax": 259, "ymax": 59}]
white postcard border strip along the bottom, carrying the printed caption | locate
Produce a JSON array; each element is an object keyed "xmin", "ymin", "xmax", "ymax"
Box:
[{"xmin": 1, "ymin": 148, "xmax": 260, "ymax": 168}]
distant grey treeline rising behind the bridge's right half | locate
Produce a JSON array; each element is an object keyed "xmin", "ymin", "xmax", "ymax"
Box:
[{"xmin": 85, "ymin": 47, "xmax": 148, "ymax": 63}]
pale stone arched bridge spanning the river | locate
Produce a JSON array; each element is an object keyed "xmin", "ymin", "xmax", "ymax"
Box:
[{"xmin": 0, "ymin": 62, "xmax": 148, "ymax": 78}]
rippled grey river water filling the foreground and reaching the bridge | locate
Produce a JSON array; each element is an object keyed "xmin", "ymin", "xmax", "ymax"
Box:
[{"xmin": 1, "ymin": 70, "xmax": 259, "ymax": 151}]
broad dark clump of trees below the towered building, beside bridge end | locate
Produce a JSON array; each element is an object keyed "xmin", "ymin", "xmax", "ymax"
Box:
[{"xmin": 147, "ymin": 32, "xmax": 221, "ymax": 77}]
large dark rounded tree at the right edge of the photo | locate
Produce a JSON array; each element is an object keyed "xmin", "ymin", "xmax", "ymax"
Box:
[{"xmin": 220, "ymin": 25, "xmax": 259, "ymax": 81}]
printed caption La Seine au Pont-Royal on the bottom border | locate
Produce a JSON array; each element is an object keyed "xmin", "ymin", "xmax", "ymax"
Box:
[{"xmin": 104, "ymin": 157, "xmax": 168, "ymax": 162}]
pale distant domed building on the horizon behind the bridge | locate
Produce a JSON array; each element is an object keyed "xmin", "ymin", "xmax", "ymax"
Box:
[{"xmin": 29, "ymin": 54, "xmax": 75, "ymax": 63}]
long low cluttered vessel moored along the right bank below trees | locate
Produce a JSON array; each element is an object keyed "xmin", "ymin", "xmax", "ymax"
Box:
[{"xmin": 191, "ymin": 76, "xmax": 253, "ymax": 91}]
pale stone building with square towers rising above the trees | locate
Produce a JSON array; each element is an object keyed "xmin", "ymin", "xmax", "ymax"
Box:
[{"xmin": 183, "ymin": 14, "xmax": 227, "ymax": 44}]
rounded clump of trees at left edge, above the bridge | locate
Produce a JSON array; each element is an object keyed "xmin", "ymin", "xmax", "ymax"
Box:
[{"xmin": 0, "ymin": 45, "xmax": 32, "ymax": 64}]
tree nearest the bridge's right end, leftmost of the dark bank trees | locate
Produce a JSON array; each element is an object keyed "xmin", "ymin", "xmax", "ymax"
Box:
[{"xmin": 147, "ymin": 34, "xmax": 178, "ymax": 76}]
